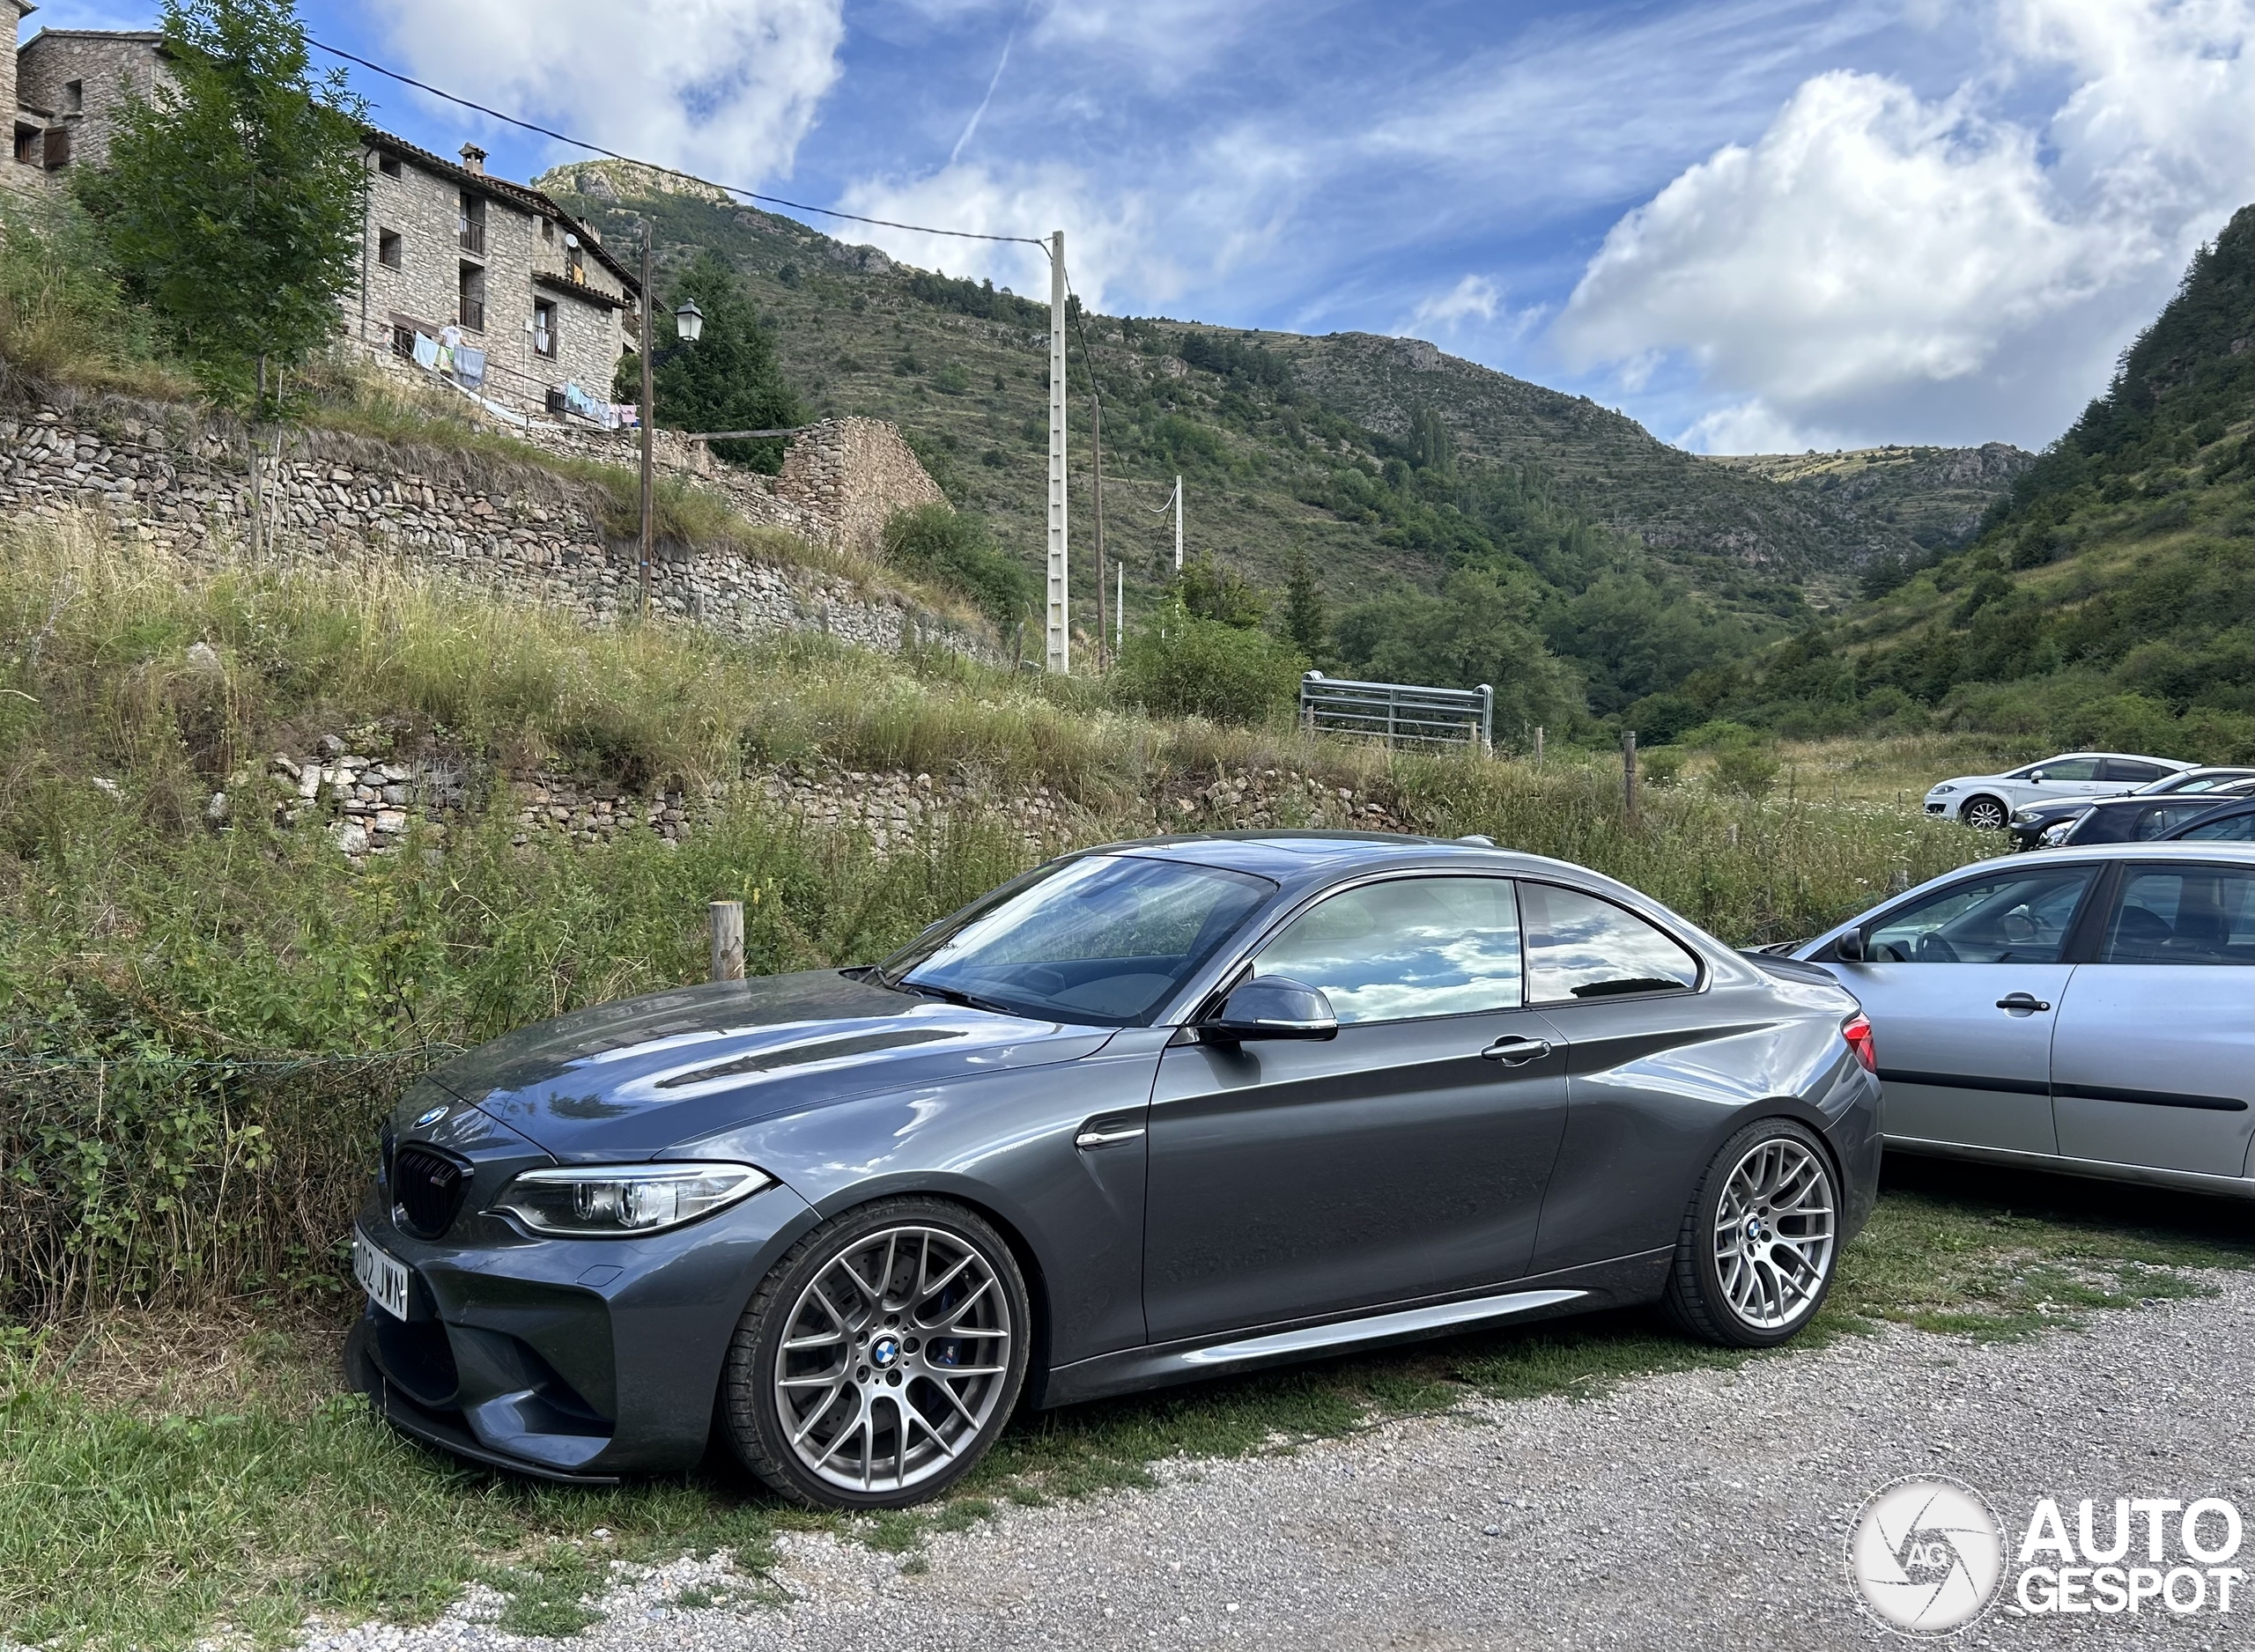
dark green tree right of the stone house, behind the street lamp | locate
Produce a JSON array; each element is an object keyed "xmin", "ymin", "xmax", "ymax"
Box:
[{"xmin": 617, "ymin": 250, "xmax": 805, "ymax": 476}]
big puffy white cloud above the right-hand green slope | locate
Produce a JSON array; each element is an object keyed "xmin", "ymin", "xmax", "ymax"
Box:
[{"xmin": 1556, "ymin": 0, "xmax": 2255, "ymax": 448}]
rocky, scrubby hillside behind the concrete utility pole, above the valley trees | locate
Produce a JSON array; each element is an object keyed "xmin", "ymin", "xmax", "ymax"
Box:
[{"xmin": 541, "ymin": 162, "xmax": 2009, "ymax": 624}]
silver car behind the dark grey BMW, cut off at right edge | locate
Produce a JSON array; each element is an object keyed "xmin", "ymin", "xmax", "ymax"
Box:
[{"xmin": 1793, "ymin": 843, "xmax": 2255, "ymax": 1197}]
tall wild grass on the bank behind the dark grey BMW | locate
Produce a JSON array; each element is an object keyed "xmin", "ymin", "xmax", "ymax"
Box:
[{"xmin": 0, "ymin": 523, "xmax": 1973, "ymax": 1318}]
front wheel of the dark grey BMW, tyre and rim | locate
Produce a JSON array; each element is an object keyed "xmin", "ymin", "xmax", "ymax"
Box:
[{"xmin": 720, "ymin": 1197, "xmax": 1032, "ymax": 1510}]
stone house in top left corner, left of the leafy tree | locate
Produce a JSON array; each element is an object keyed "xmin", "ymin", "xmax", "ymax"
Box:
[{"xmin": 0, "ymin": 0, "xmax": 166, "ymax": 192}]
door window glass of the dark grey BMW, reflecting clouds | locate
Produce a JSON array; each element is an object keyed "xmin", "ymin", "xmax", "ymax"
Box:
[{"xmin": 1253, "ymin": 877, "xmax": 1519, "ymax": 1026}]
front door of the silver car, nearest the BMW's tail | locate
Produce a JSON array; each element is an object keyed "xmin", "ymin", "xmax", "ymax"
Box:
[{"xmin": 1827, "ymin": 861, "xmax": 2097, "ymax": 1154}]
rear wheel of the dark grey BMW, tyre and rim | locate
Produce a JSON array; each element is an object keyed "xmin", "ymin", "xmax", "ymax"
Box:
[{"xmin": 1660, "ymin": 1117, "xmax": 1840, "ymax": 1347}]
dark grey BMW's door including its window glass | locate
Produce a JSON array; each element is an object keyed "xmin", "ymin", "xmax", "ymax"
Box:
[{"xmin": 1143, "ymin": 874, "xmax": 1565, "ymax": 1343}]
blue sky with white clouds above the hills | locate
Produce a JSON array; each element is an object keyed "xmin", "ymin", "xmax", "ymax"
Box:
[{"xmin": 32, "ymin": 0, "xmax": 2255, "ymax": 451}]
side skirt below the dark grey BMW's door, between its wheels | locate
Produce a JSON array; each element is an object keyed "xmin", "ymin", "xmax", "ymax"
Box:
[{"xmin": 1038, "ymin": 1249, "xmax": 1674, "ymax": 1411}]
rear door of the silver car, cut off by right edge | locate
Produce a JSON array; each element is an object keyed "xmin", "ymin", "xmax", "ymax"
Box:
[{"xmin": 2052, "ymin": 859, "xmax": 2255, "ymax": 1176}]
